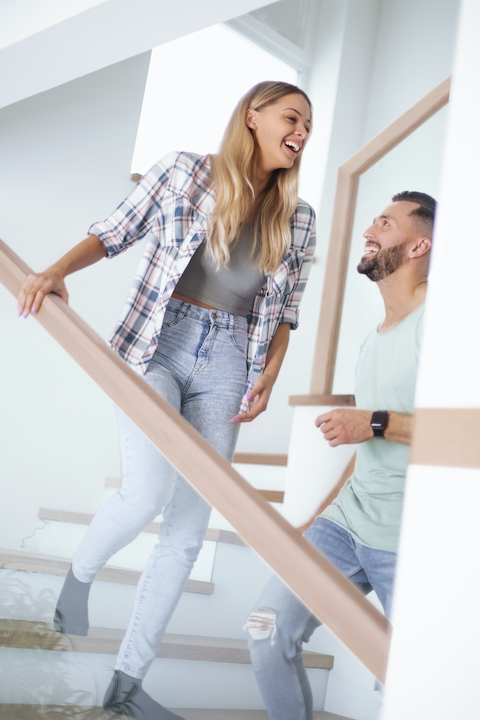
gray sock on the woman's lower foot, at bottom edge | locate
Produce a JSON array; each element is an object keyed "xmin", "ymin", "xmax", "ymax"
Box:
[{"xmin": 103, "ymin": 670, "xmax": 184, "ymax": 720}]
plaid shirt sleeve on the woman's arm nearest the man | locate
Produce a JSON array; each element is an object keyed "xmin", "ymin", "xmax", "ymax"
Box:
[{"xmin": 280, "ymin": 206, "xmax": 316, "ymax": 330}]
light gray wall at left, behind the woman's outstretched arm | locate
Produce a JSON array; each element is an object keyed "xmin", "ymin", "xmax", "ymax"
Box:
[{"xmin": 0, "ymin": 53, "xmax": 149, "ymax": 547}]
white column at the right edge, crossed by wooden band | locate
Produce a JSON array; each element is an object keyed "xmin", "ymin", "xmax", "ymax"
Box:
[{"xmin": 382, "ymin": 0, "xmax": 480, "ymax": 720}]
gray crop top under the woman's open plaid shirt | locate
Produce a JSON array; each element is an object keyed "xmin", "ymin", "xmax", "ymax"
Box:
[{"xmin": 175, "ymin": 224, "xmax": 265, "ymax": 316}]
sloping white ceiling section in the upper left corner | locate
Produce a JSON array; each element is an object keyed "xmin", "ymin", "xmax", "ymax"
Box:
[{"xmin": 0, "ymin": 0, "xmax": 278, "ymax": 107}]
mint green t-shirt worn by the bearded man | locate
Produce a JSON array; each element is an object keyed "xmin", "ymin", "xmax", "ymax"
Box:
[{"xmin": 322, "ymin": 304, "xmax": 424, "ymax": 552}]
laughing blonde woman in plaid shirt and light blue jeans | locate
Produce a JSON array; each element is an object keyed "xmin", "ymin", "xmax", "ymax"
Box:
[{"xmin": 18, "ymin": 82, "xmax": 315, "ymax": 720}]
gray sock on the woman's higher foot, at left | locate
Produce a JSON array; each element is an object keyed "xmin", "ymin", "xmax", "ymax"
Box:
[{"xmin": 53, "ymin": 568, "xmax": 92, "ymax": 635}]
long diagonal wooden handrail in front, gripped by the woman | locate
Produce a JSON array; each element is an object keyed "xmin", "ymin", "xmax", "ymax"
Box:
[{"xmin": 0, "ymin": 241, "xmax": 390, "ymax": 682}]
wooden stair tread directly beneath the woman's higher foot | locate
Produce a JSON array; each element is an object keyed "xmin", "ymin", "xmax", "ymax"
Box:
[{"xmin": 0, "ymin": 619, "xmax": 333, "ymax": 670}]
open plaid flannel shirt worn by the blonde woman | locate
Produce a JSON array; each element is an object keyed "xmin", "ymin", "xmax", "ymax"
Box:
[{"xmin": 88, "ymin": 152, "xmax": 315, "ymax": 412}]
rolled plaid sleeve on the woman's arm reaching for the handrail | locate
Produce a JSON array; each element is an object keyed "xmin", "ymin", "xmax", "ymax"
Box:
[{"xmin": 88, "ymin": 153, "xmax": 178, "ymax": 258}]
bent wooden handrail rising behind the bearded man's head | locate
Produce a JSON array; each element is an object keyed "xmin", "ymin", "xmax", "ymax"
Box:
[{"xmin": 310, "ymin": 78, "xmax": 450, "ymax": 395}]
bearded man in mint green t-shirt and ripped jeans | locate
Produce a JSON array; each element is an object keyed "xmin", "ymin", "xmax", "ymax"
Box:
[{"xmin": 246, "ymin": 191, "xmax": 435, "ymax": 720}]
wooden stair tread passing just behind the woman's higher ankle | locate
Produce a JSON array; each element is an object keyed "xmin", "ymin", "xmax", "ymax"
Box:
[{"xmin": 0, "ymin": 549, "xmax": 215, "ymax": 595}]
